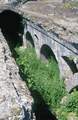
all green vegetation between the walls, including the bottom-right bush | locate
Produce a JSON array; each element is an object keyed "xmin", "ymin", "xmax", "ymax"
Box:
[{"xmin": 13, "ymin": 48, "xmax": 78, "ymax": 120}]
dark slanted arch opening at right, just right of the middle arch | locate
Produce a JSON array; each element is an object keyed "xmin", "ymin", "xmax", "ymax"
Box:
[{"xmin": 62, "ymin": 56, "xmax": 78, "ymax": 74}]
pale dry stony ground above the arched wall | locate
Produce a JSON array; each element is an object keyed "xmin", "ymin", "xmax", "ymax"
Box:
[{"xmin": 19, "ymin": 1, "xmax": 78, "ymax": 43}]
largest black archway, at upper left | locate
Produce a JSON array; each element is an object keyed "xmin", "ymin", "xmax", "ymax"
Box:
[{"xmin": 0, "ymin": 10, "xmax": 24, "ymax": 50}]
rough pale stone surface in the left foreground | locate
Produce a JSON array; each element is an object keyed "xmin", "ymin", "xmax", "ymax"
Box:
[{"xmin": 0, "ymin": 31, "xmax": 34, "ymax": 120}]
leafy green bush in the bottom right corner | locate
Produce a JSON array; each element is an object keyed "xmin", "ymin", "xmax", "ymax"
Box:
[{"xmin": 57, "ymin": 91, "xmax": 78, "ymax": 120}]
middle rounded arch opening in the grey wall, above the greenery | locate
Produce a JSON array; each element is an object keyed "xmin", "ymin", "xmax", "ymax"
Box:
[{"xmin": 40, "ymin": 45, "xmax": 57, "ymax": 62}]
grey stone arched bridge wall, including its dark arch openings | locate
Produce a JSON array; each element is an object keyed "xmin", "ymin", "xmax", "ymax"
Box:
[{"xmin": 0, "ymin": 5, "xmax": 78, "ymax": 92}]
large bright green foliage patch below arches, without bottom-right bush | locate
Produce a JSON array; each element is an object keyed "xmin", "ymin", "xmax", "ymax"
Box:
[{"xmin": 16, "ymin": 48, "xmax": 65, "ymax": 109}]
